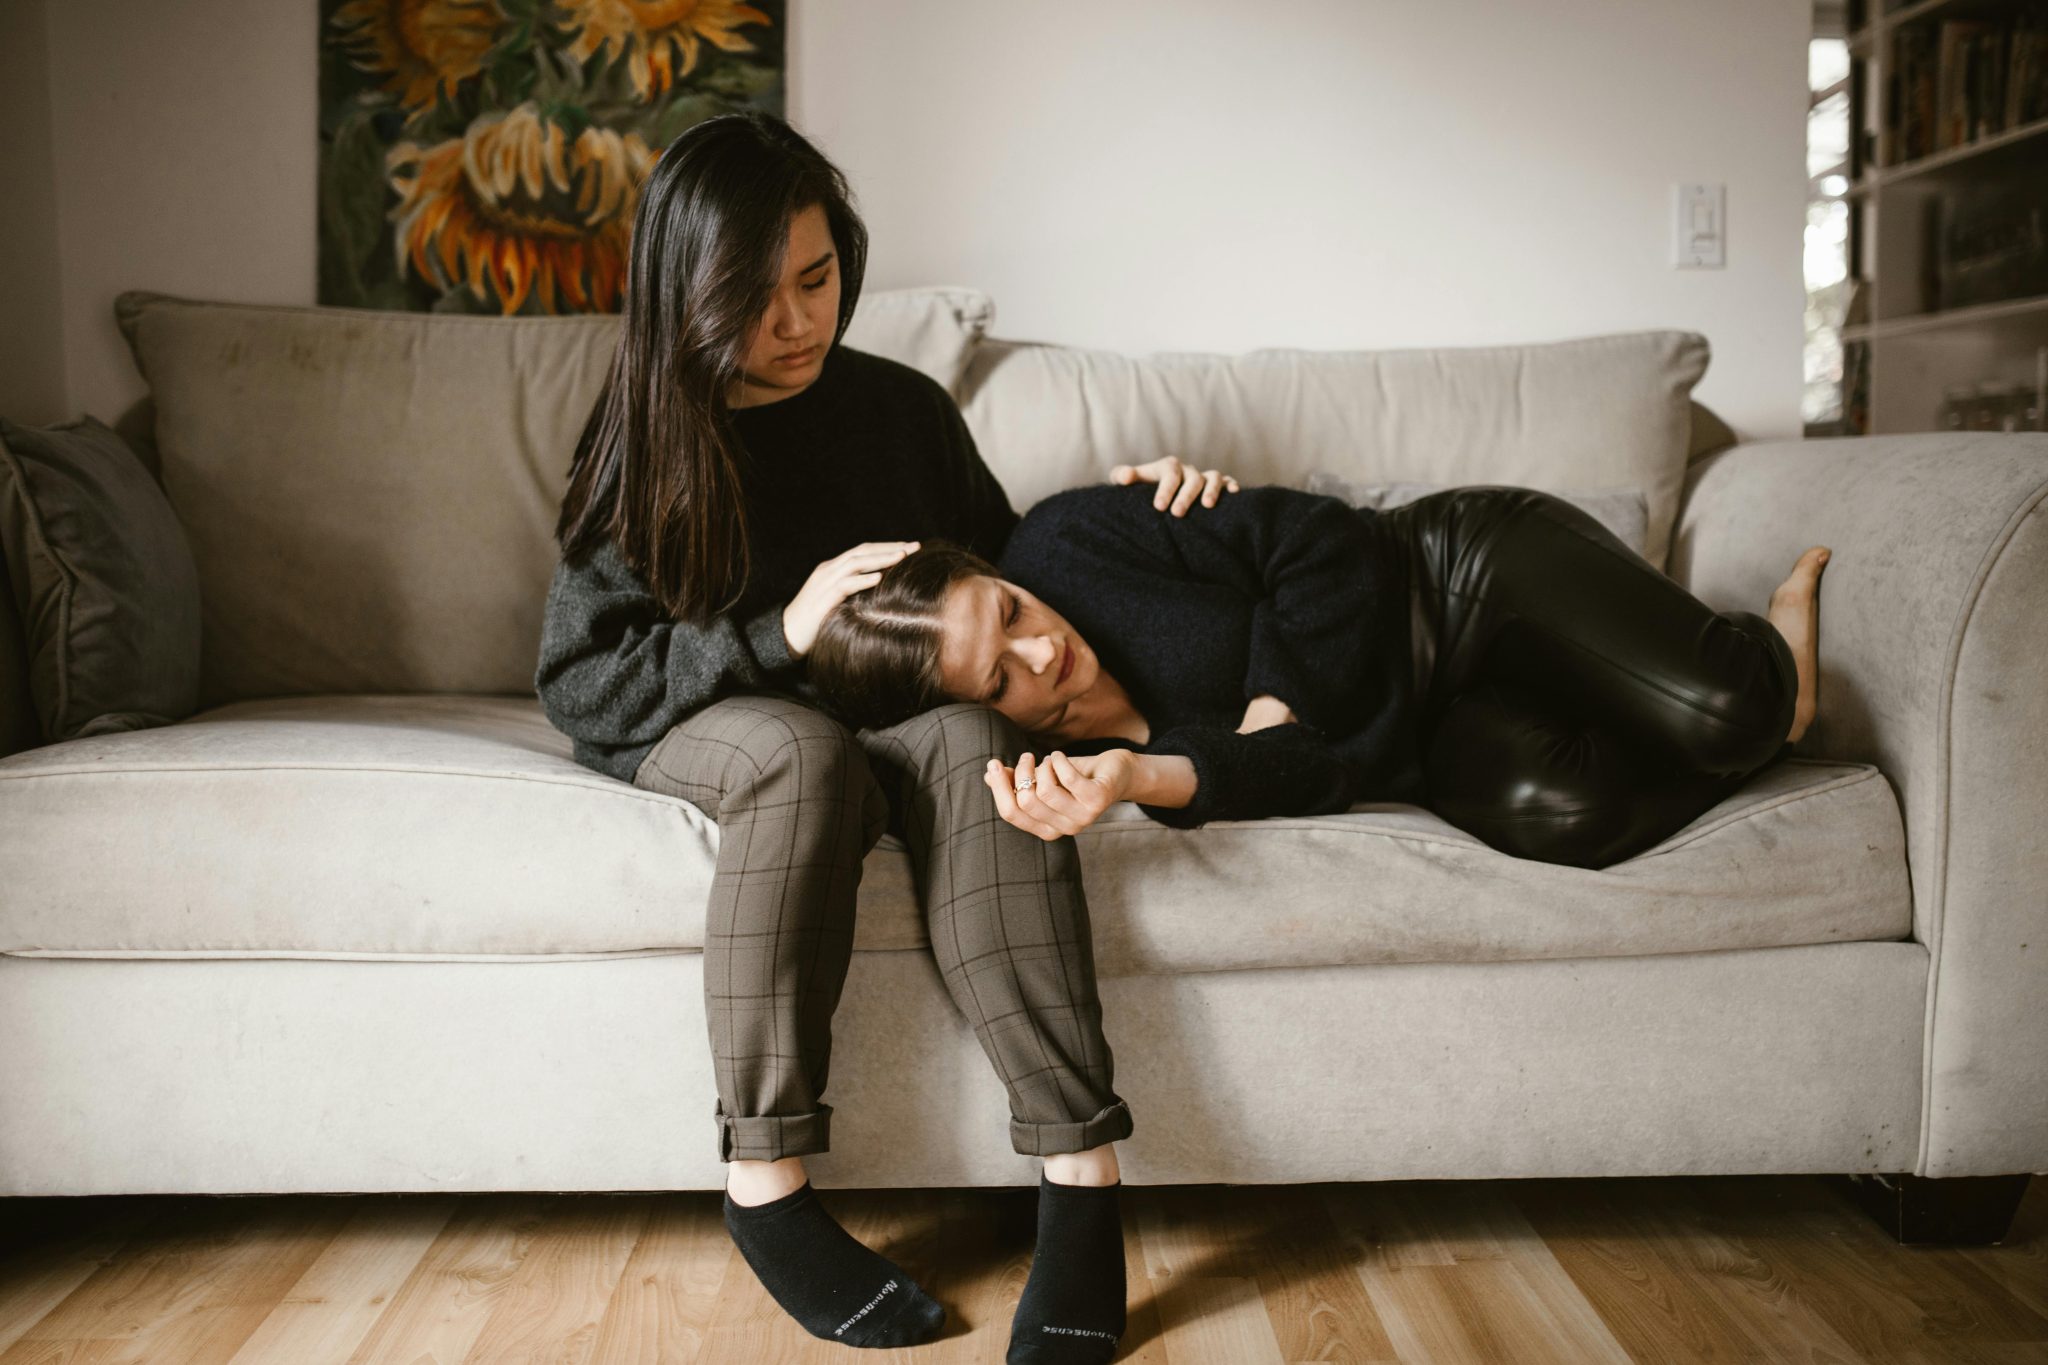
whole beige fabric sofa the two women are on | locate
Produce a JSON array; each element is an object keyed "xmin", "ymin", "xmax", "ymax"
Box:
[{"xmin": 0, "ymin": 289, "xmax": 2048, "ymax": 1236}]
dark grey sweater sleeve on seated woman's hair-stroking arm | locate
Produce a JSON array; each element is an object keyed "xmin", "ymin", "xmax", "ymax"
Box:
[{"xmin": 532, "ymin": 540, "xmax": 797, "ymax": 749}]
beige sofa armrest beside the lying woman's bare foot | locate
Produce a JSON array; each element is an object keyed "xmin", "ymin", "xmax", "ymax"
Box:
[{"xmin": 1671, "ymin": 432, "xmax": 2048, "ymax": 1177}]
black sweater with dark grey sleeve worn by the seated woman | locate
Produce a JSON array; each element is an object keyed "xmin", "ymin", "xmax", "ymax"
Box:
[{"xmin": 535, "ymin": 344, "xmax": 1019, "ymax": 782}]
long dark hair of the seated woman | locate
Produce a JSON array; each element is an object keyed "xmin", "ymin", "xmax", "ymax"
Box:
[{"xmin": 555, "ymin": 111, "xmax": 868, "ymax": 622}]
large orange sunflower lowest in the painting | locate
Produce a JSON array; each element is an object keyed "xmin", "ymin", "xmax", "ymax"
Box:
[{"xmin": 385, "ymin": 100, "xmax": 655, "ymax": 313}]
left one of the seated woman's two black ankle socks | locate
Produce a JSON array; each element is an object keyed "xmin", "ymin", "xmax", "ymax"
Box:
[{"xmin": 725, "ymin": 1181, "xmax": 946, "ymax": 1347}]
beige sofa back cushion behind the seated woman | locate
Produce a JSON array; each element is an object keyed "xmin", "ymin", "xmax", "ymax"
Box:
[{"xmin": 117, "ymin": 289, "xmax": 989, "ymax": 708}]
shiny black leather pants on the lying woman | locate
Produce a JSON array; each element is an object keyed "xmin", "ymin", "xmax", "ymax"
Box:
[{"xmin": 1380, "ymin": 485, "xmax": 1798, "ymax": 868}]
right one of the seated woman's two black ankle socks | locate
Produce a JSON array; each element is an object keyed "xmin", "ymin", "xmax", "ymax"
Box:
[{"xmin": 1006, "ymin": 1175, "xmax": 1124, "ymax": 1365}]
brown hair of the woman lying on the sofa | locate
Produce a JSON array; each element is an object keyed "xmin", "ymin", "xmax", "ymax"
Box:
[{"xmin": 807, "ymin": 540, "xmax": 997, "ymax": 731}]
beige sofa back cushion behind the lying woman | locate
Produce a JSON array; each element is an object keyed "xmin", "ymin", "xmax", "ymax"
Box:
[{"xmin": 965, "ymin": 329, "xmax": 1710, "ymax": 569}]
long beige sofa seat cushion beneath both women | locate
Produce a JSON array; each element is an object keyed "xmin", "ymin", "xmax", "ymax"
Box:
[{"xmin": 0, "ymin": 696, "xmax": 1911, "ymax": 976}]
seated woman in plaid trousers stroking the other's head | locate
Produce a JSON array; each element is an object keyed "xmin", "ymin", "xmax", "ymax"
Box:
[{"xmin": 535, "ymin": 113, "xmax": 1235, "ymax": 1363}]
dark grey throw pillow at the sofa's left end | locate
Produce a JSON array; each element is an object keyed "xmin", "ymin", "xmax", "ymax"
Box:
[{"xmin": 0, "ymin": 417, "xmax": 199, "ymax": 743}]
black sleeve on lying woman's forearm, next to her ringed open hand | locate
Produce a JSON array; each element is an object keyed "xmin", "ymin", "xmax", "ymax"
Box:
[{"xmin": 1139, "ymin": 722, "xmax": 1352, "ymax": 829}]
